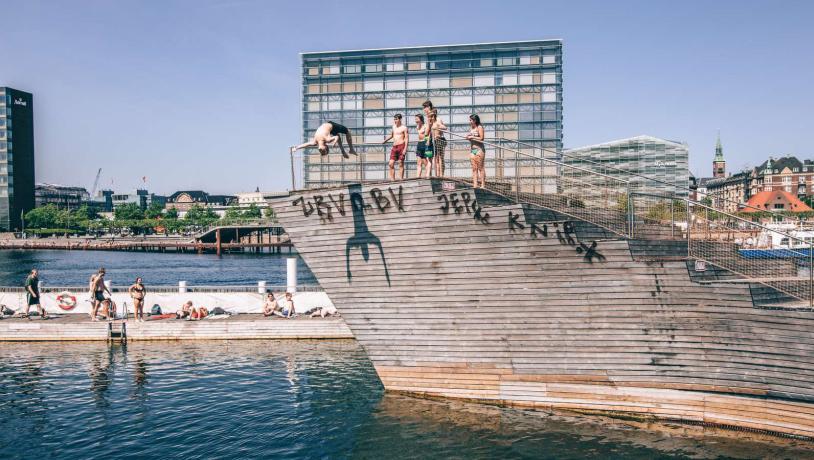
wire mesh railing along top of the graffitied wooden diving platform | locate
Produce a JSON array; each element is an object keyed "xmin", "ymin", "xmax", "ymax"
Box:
[{"xmin": 291, "ymin": 131, "xmax": 814, "ymax": 307}]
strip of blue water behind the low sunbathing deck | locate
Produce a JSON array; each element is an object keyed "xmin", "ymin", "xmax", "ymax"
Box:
[{"xmin": 0, "ymin": 250, "xmax": 316, "ymax": 286}]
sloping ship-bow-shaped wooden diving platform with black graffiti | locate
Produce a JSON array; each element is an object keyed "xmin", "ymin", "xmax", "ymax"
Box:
[{"xmin": 272, "ymin": 139, "xmax": 814, "ymax": 437}]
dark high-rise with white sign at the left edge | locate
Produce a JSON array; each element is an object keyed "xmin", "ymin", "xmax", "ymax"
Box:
[{"xmin": 0, "ymin": 87, "xmax": 34, "ymax": 231}]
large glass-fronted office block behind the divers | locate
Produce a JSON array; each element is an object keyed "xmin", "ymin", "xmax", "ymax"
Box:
[{"xmin": 299, "ymin": 40, "xmax": 562, "ymax": 187}]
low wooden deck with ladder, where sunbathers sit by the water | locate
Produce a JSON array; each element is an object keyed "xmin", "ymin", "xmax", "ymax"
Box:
[{"xmin": 0, "ymin": 314, "xmax": 353, "ymax": 342}]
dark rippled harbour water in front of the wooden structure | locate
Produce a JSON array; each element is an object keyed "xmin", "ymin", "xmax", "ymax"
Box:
[{"xmin": 0, "ymin": 341, "xmax": 812, "ymax": 459}]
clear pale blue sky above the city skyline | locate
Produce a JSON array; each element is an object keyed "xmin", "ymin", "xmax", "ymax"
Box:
[{"xmin": 0, "ymin": 0, "xmax": 814, "ymax": 193}]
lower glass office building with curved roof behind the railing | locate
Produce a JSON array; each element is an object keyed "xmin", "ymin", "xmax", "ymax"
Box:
[{"xmin": 562, "ymin": 136, "xmax": 690, "ymax": 197}]
